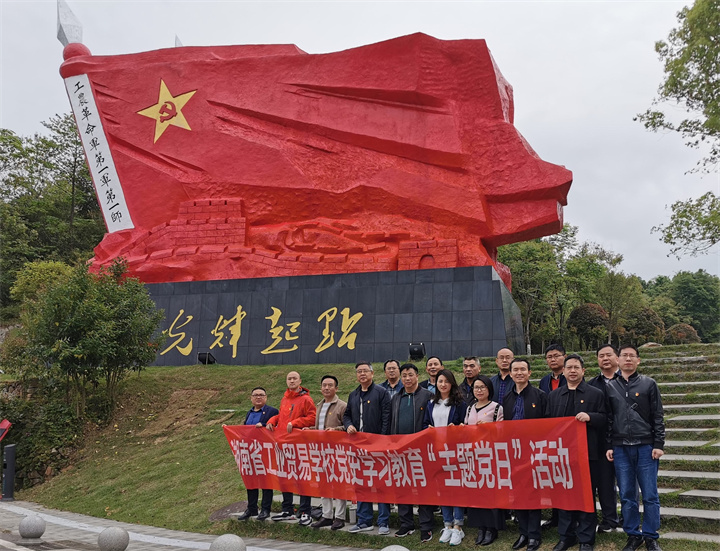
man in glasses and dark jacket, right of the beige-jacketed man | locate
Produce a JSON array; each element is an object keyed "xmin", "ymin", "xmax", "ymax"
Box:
[{"xmin": 343, "ymin": 362, "xmax": 390, "ymax": 535}]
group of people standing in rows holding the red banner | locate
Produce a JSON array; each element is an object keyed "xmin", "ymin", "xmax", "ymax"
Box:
[{"xmin": 240, "ymin": 344, "xmax": 665, "ymax": 551}]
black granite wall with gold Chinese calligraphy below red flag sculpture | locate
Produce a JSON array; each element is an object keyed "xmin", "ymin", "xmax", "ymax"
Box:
[{"xmin": 147, "ymin": 266, "xmax": 523, "ymax": 365}]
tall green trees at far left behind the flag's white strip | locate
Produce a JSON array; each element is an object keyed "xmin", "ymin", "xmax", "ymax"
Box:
[{"xmin": 0, "ymin": 115, "xmax": 105, "ymax": 319}]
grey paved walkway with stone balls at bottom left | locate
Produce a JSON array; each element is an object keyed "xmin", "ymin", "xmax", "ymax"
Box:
[{"xmin": 0, "ymin": 501, "xmax": 363, "ymax": 551}]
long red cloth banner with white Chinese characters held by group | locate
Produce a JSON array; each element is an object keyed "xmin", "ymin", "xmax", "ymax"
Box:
[{"xmin": 224, "ymin": 417, "xmax": 595, "ymax": 512}]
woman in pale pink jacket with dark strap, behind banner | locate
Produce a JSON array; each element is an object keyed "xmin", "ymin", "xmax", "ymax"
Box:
[{"xmin": 465, "ymin": 375, "xmax": 505, "ymax": 545}]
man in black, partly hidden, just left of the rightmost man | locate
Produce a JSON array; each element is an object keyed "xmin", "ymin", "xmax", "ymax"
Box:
[{"xmin": 588, "ymin": 344, "xmax": 620, "ymax": 532}]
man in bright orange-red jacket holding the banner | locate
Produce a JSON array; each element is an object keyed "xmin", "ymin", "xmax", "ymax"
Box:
[{"xmin": 265, "ymin": 371, "xmax": 316, "ymax": 526}]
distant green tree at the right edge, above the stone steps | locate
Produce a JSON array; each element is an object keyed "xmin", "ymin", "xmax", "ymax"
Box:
[{"xmin": 670, "ymin": 270, "xmax": 720, "ymax": 342}]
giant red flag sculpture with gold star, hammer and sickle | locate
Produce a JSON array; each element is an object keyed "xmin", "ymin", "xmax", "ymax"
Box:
[{"xmin": 60, "ymin": 34, "xmax": 572, "ymax": 283}]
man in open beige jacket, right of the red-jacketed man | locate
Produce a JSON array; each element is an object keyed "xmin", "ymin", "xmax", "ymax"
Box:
[{"xmin": 303, "ymin": 375, "xmax": 347, "ymax": 530}]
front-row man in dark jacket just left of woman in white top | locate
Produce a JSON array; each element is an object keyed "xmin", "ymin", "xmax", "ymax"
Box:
[{"xmin": 390, "ymin": 363, "xmax": 435, "ymax": 542}]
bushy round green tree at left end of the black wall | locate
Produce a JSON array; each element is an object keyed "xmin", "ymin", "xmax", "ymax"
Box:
[{"xmin": 3, "ymin": 262, "xmax": 163, "ymax": 417}]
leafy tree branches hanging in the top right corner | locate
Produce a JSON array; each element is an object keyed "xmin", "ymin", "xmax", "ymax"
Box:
[{"xmin": 637, "ymin": 0, "xmax": 720, "ymax": 169}]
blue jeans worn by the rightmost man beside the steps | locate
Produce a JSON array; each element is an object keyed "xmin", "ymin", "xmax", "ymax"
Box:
[{"xmin": 613, "ymin": 444, "xmax": 660, "ymax": 539}]
